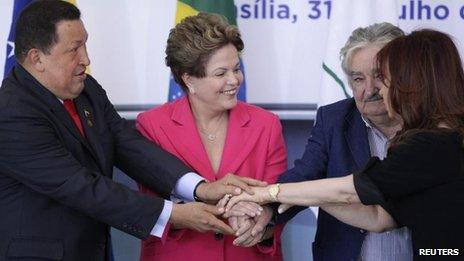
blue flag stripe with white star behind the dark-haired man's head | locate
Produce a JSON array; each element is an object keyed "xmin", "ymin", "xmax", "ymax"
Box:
[{"xmin": 3, "ymin": 0, "xmax": 32, "ymax": 78}]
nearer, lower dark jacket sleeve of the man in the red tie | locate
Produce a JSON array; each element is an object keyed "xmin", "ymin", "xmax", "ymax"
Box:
[{"xmin": 0, "ymin": 99, "xmax": 164, "ymax": 238}]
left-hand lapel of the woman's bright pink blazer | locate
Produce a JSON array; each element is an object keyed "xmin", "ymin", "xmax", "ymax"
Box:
[{"xmin": 160, "ymin": 98, "xmax": 216, "ymax": 181}]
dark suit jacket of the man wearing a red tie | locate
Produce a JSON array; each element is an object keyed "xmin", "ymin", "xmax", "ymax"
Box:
[{"xmin": 0, "ymin": 66, "xmax": 190, "ymax": 261}]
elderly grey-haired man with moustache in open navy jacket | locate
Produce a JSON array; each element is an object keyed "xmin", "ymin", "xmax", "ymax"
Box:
[{"xmin": 277, "ymin": 23, "xmax": 412, "ymax": 261}]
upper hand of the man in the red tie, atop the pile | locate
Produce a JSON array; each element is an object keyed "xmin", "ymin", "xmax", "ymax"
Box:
[{"xmin": 195, "ymin": 173, "xmax": 267, "ymax": 203}]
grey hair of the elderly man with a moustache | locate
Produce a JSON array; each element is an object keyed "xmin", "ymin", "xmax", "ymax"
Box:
[{"xmin": 340, "ymin": 22, "xmax": 404, "ymax": 75}]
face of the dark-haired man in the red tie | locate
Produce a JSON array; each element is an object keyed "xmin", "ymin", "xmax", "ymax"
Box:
[{"xmin": 39, "ymin": 20, "xmax": 90, "ymax": 99}]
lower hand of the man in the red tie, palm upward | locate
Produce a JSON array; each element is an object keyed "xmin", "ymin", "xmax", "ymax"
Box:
[{"xmin": 169, "ymin": 202, "xmax": 235, "ymax": 235}]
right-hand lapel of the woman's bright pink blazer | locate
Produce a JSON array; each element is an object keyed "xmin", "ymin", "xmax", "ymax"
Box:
[{"xmin": 218, "ymin": 102, "xmax": 263, "ymax": 178}]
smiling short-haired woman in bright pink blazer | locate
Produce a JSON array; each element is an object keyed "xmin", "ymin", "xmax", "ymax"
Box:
[{"xmin": 137, "ymin": 13, "xmax": 287, "ymax": 261}]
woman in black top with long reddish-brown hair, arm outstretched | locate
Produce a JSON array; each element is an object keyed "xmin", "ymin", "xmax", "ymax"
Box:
[{"xmin": 227, "ymin": 30, "xmax": 464, "ymax": 260}]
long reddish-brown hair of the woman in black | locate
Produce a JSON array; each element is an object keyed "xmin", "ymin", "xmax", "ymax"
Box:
[{"xmin": 377, "ymin": 29, "xmax": 464, "ymax": 146}]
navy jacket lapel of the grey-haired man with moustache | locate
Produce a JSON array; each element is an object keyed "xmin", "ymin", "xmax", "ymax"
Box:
[{"xmin": 344, "ymin": 106, "xmax": 371, "ymax": 169}]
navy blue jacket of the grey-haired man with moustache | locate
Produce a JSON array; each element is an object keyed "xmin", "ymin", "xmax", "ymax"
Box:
[{"xmin": 278, "ymin": 99, "xmax": 370, "ymax": 261}]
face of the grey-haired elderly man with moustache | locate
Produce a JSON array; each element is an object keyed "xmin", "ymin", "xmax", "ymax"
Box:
[{"xmin": 348, "ymin": 45, "xmax": 387, "ymax": 118}]
